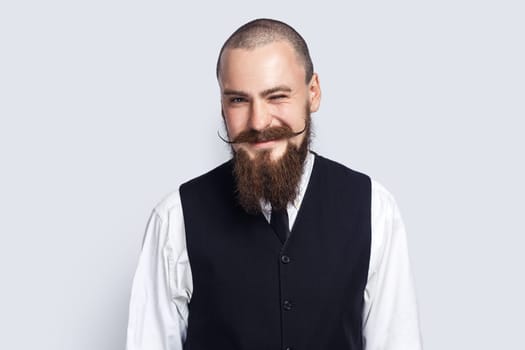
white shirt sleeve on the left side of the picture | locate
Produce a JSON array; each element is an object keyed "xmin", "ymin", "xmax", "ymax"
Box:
[{"xmin": 126, "ymin": 194, "xmax": 192, "ymax": 350}]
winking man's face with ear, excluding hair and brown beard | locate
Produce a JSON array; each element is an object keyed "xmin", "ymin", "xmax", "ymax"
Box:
[{"xmin": 219, "ymin": 41, "xmax": 321, "ymax": 161}]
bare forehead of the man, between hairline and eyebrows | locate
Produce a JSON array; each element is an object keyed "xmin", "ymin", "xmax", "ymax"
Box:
[{"xmin": 219, "ymin": 41, "xmax": 306, "ymax": 90}]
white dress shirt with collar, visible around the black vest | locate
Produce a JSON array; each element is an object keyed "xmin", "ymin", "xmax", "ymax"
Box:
[{"xmin": 126, "ymin": 153, "xmax": 422, "ymax": 350}]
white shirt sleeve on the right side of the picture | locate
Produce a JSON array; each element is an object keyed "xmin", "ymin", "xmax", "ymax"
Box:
[{"xmin": 363, "ymin": 181, "xmax": 422, "ymax": 350}]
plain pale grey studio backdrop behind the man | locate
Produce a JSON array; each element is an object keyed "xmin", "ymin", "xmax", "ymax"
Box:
[{"xmin": 0, "ymin": 0, "xmax": 525, "ymax": 350}]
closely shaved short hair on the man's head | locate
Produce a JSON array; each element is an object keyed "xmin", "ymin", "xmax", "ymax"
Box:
[{"xmin": 216, "ymin": 18, "xmax": 314, "ymax": 84}]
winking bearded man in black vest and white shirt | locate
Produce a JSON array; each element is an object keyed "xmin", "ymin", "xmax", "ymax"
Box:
[{"xmin": 127, "ymin": 19, "xmax": 421, "ymax": 350}]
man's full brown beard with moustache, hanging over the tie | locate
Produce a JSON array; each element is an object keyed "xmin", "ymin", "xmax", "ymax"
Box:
[{"xmin": 232, "ymin": 109, "xmax": 311, "ymax": 214}]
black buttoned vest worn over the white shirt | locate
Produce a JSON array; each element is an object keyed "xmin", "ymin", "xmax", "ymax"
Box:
[{"xmin": 180, "ymin": 155, "xmax": 371, "ymax": 350}]
